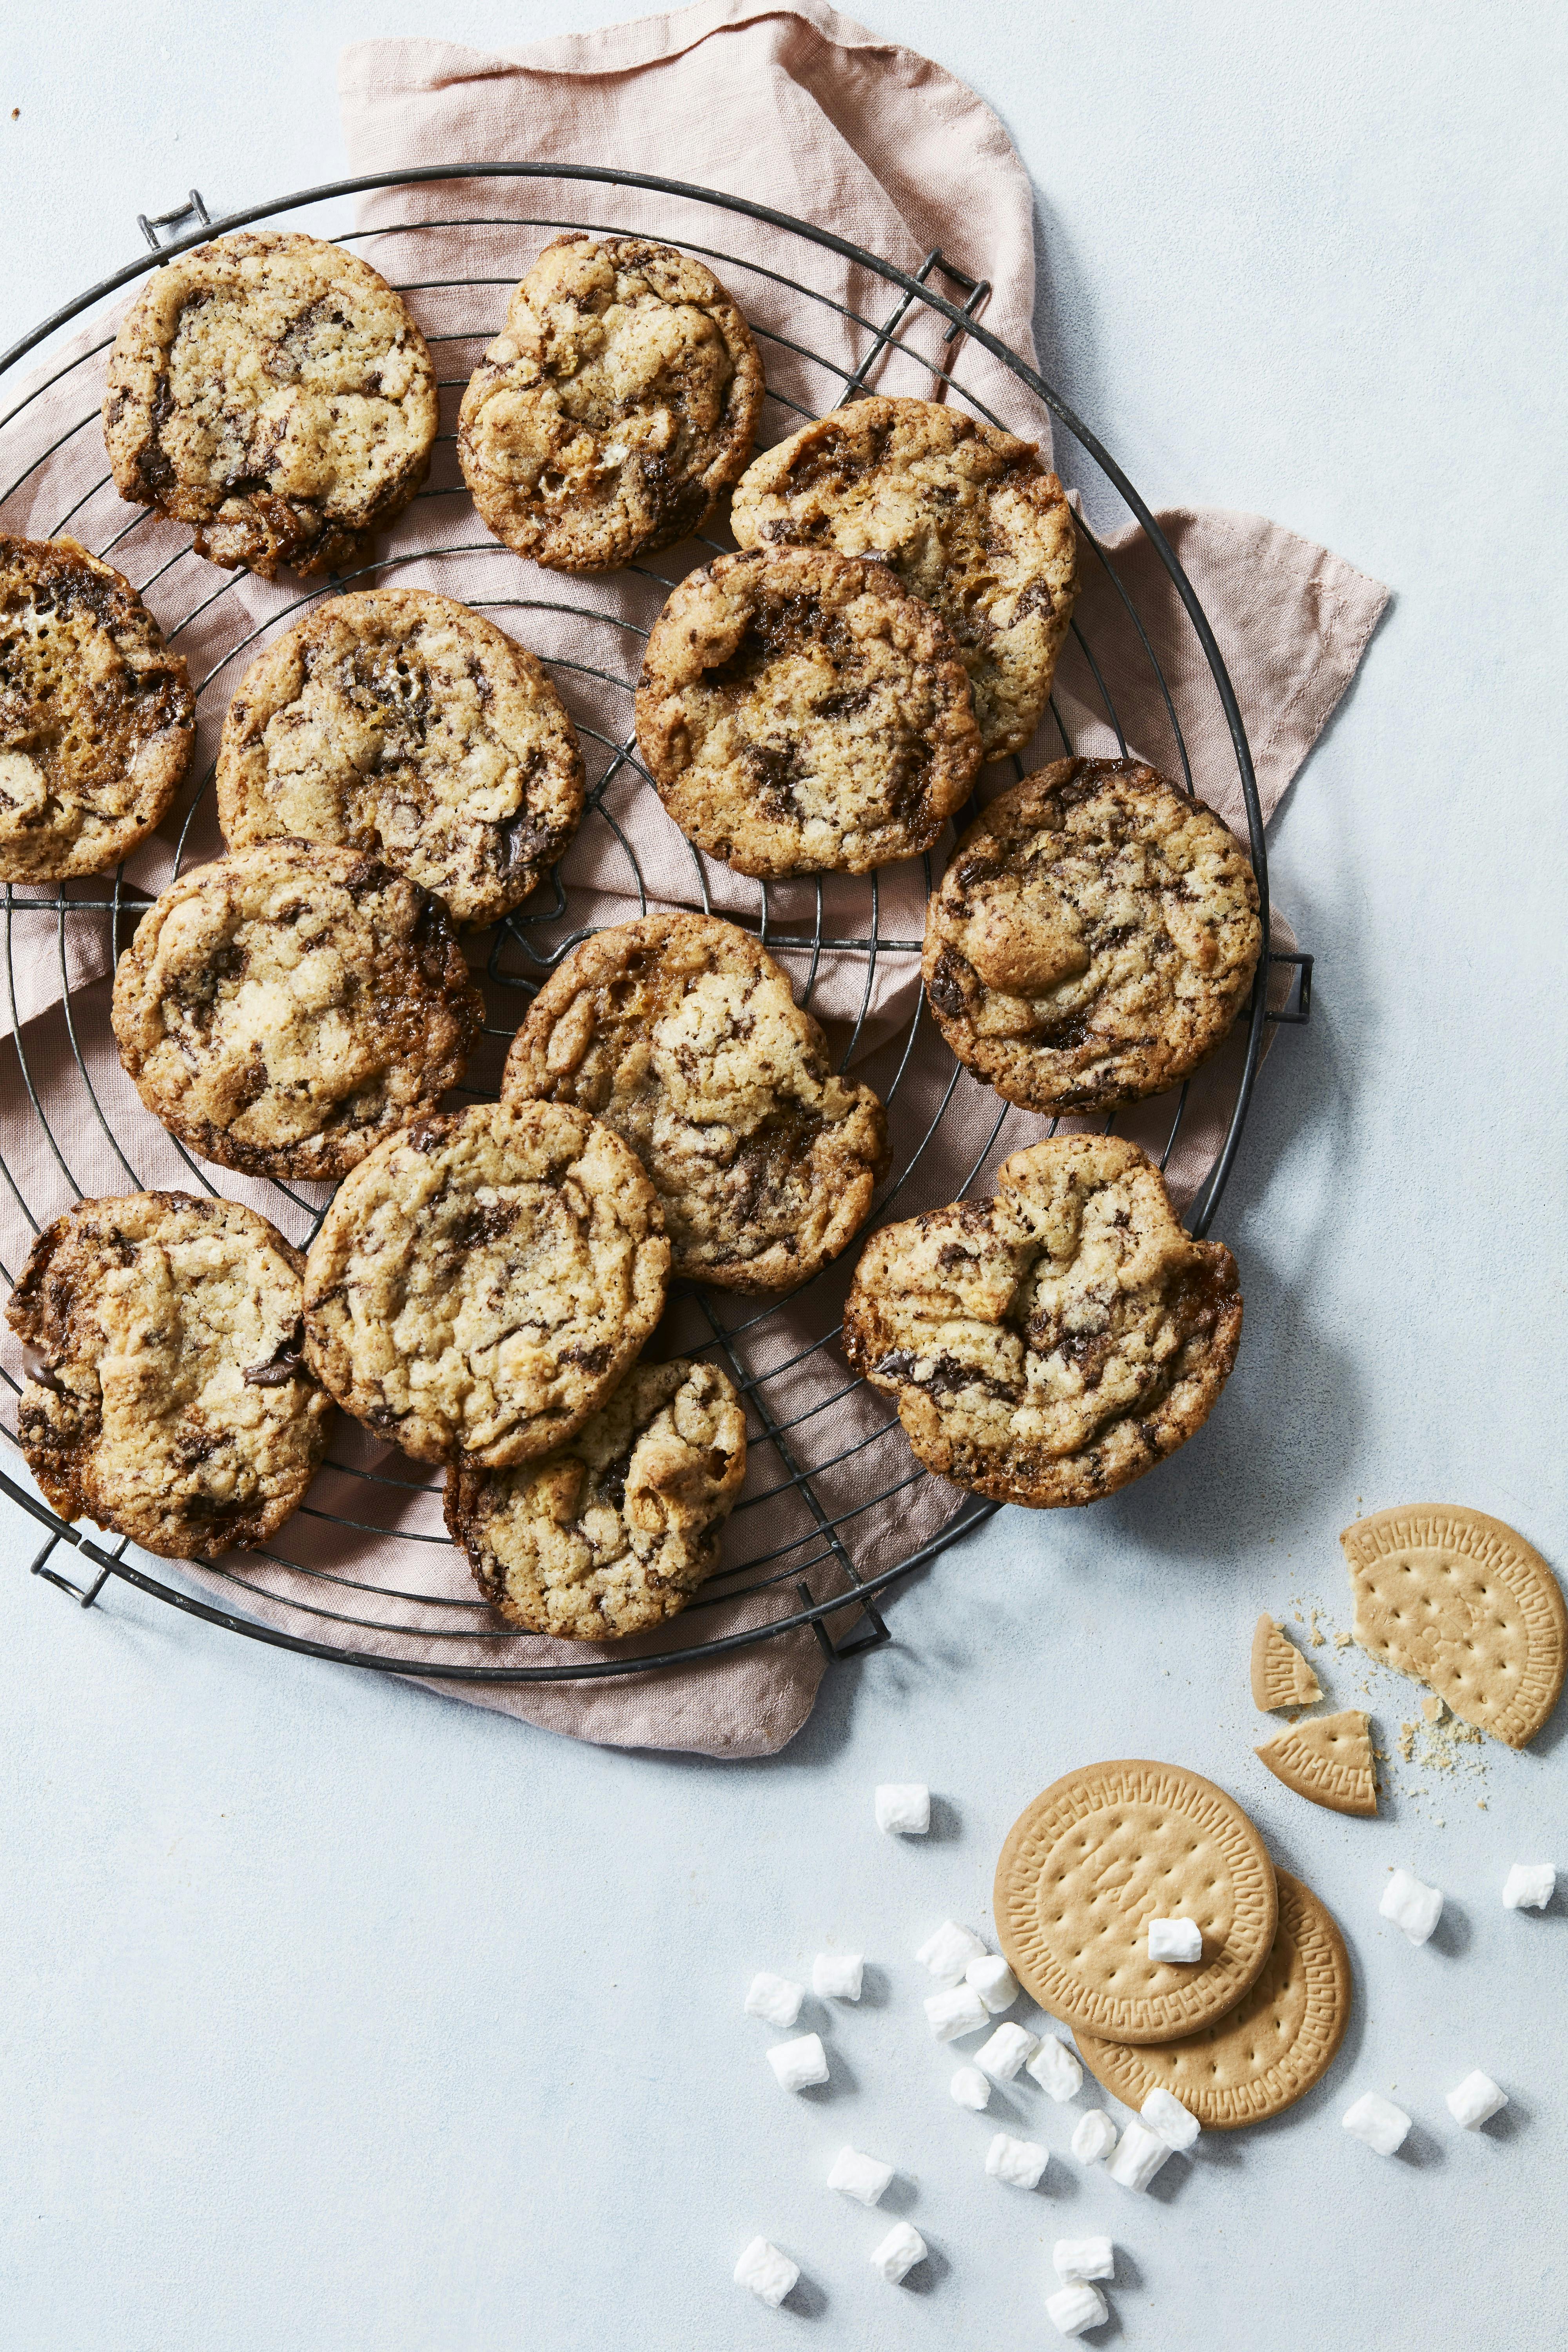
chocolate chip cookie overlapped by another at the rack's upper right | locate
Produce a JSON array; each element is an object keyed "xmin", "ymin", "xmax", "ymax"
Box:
[{"xmin": 729, "ymin": 395, "xmax": 1077, "ymax": 760}]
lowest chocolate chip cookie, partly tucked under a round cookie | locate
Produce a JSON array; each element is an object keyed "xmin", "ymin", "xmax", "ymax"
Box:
[{"xmin": 446, "ymin": 1357, "xmax": 745, "ymax": 1642}]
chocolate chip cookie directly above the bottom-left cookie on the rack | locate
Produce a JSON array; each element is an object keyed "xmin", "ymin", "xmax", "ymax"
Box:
[{"xmin": 113, "ymin": 840, "xmax": 484, "ymax": 1178}]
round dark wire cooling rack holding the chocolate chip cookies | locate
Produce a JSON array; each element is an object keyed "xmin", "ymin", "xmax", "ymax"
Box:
[{"xmin": 0, "ymin": 162, "xmax": 1312, "ymax": 1686}]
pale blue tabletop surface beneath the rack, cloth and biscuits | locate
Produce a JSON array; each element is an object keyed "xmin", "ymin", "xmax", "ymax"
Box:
[{"xmin": 0, "ymin": 0, "xmax": 1568, "ymax": 2352}]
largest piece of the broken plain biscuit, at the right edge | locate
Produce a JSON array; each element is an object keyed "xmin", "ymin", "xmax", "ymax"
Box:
[{"xmin": 1340, "ymin": 1503, "xmax": 1568, "ymax": 1748}]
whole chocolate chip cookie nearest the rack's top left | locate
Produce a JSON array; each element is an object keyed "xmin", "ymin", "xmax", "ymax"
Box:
[{"xmin": 103, "ymin": 230, "xmax": 435, "ymax": 581}]
